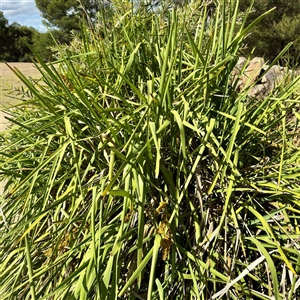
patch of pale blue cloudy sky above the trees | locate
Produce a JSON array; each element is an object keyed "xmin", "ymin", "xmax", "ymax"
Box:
[{"xmin": 0, "ymin": 0, "xmax": 47, "ymax": 32}]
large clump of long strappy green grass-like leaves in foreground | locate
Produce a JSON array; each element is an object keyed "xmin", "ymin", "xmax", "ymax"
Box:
[{"xmin": 0, "ymin": 0, "xmax": 300, "ymax": 300}]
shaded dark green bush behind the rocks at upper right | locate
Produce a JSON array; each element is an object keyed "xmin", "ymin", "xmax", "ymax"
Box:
[{"xmin": 240, "ymin": 0, "xmax": 300, "ymax": 66}]
